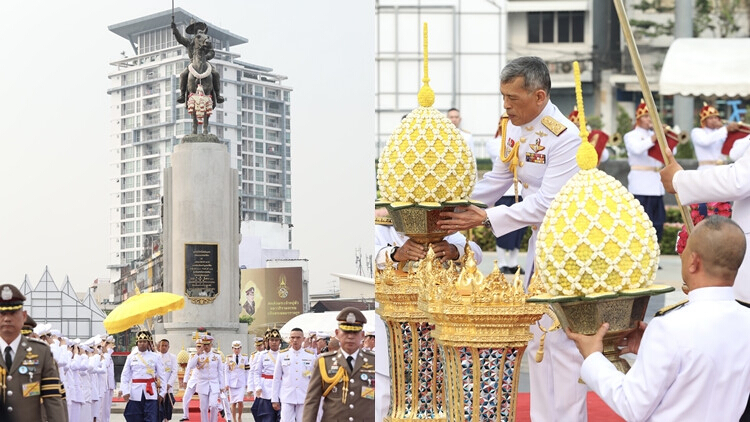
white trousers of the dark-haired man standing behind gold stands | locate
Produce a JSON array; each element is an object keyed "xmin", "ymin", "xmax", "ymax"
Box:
[{"xmin": 526, "ymin": 315, "xmax": 588, "ymax": 422}]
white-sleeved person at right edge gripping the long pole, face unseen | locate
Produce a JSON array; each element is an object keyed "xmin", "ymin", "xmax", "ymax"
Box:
[{"xmin": 661, "ymin": 139, "xmax": 750, "ymax": 421}]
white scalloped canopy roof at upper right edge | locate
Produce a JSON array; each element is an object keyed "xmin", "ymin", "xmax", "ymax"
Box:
[{"xmin": 659, "ymin": 38, "xmax": 750, "ymax": 97}]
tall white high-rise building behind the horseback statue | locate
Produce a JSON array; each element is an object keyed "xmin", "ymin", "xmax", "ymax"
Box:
[{"xmin": 108, "ymin": 8, "xmax": 292, "ymax": 280}]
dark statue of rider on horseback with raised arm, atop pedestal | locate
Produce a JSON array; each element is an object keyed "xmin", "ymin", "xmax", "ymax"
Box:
[{"xmin": 172, "ymin": 17, "xmax": 224, "ymax": 135}]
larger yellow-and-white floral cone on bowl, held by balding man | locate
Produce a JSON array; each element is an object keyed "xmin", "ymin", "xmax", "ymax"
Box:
[{"xmin": 529, "ymin": 63, "xmax": 674, "ymax": 372}]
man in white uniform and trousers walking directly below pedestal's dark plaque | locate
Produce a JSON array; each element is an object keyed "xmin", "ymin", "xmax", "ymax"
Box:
[{"xmin": 195, "ymin": 335, "xmax": 224, "ymax": 422}]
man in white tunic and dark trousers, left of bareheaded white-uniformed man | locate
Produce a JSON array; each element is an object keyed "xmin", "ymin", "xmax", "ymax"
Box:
[{"xmin": 250, "ymin": 328, "xmax": 281, "ymax": 422}]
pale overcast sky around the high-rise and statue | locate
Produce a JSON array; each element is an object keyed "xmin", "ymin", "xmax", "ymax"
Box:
[{"xmin": 0, "ymin": 0, "xmax": 375, "ymax": 291}]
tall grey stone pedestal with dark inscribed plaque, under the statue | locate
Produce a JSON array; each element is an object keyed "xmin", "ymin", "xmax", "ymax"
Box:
[{"xmin": 163, "ymin": 142, "xmax": 250, "ymax": 354}]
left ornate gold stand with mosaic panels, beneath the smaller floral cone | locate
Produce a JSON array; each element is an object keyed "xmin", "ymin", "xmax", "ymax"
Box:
[{"xmin": 375, "ymin": 263, "xmax": 445, "ymax": 422}]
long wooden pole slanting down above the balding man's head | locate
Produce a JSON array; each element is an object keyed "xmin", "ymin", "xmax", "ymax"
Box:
[{"xmin": 613, "ymin": 0, "xmax": 693, "ymax": 234}]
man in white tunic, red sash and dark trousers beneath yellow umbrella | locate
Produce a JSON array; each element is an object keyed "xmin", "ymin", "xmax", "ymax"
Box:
[{"xmin": 120, "ymin": 331, "xmax": 167, "ymax": 422}]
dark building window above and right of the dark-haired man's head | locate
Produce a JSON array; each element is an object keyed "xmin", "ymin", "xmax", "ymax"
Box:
[{"xmin": 526, "ymin": 11, "xmax": 584, "ymax": 44}]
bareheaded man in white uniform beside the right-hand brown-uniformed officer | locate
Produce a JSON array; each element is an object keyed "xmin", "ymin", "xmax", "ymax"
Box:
[{"xmin": 271, "ymin": 328, "xmax": 315, "ymax": 422}]
